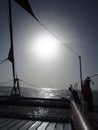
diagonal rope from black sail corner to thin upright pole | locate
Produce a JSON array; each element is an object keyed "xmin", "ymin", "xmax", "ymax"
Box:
[{"xmin": 32, "ymin": 15, "xmax": 79, "ymax": 56}]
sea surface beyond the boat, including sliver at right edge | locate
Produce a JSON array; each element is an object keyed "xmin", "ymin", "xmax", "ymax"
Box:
[{"xmin": 0, "ymin": 86, "xmax": 98, "ymax": 121}]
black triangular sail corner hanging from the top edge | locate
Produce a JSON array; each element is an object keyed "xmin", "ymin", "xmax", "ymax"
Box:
[{"xmin": 15, "ymin": 0, "xmax": 38, "ymax": 20}]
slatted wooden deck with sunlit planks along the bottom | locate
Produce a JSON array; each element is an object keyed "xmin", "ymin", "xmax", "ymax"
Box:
[{"xmin": 0, "ymin": 118, "xmax": 71, "ymax": 130}]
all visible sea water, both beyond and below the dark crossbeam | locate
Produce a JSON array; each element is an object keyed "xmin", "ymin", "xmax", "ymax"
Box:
[{"xmin": 0, "ymin": 87, "xmax": 98, "ymax": 122}]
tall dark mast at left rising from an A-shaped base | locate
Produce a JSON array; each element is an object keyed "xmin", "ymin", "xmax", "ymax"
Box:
[{"xmin": 9, "ymin": 0, "xmax": 20, "ymax": 96}]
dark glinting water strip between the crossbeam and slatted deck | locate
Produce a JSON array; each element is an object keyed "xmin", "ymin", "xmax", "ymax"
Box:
[{"xmin": 0, "ymin": 105, "xmax": 68, "ymax": 119}]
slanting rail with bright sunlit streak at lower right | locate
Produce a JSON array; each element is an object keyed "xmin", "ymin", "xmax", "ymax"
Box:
[{"xmin": 71, "ymin": 100, "xmax": 94, "ymax": 130}]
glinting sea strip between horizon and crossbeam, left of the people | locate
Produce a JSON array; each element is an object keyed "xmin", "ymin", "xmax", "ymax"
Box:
[{"xmin": 0, "ymin": 86, "xmax": 69, "ymax": 98}]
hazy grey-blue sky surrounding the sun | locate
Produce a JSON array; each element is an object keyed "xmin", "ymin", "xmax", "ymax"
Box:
[{"xmin": 0, "ymin": 0, "xmax": 98, "ymax": 88}]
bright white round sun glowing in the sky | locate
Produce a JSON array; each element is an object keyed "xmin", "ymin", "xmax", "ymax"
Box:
[{"xmin": 33, "ymin": 35, "xmax": 57, "ymax": 59}]
